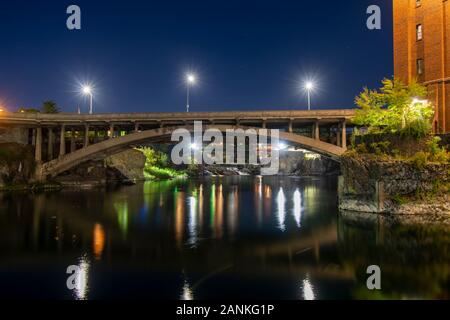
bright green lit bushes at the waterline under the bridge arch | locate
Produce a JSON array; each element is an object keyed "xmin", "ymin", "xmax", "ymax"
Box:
[{"xmin": 136, "ymin": 147, "xmax": 186, "ymax": 180}]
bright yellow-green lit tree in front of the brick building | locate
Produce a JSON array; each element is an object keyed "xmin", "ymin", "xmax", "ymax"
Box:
[{"xmin": 355, "ymin": 79, "xmax": 434, "ymax": 138}]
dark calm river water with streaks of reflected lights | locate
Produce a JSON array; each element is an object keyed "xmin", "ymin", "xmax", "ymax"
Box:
[{"xmin": 0, "ymin": 177, "xmax": 450, "ymax": 300}]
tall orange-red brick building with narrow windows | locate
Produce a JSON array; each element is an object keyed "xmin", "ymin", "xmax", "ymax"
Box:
[{"xmin": 393, "ymin": 0, "xmax": 450, "ymax": 132}]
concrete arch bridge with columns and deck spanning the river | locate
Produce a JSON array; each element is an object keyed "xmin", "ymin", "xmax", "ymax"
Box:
[{"xmin": 0, "ymin": 109, "xmax": 354, "ymax": 179}]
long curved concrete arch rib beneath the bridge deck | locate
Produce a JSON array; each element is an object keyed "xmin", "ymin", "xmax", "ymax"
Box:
[{"xmin": 37, "ymin": 125, "xmax": 346, "ymax": 179}]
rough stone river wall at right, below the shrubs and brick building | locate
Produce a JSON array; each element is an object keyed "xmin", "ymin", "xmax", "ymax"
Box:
[{"xmin": 339, "ymin": 154, "xmax": 450, "ymax": 216}]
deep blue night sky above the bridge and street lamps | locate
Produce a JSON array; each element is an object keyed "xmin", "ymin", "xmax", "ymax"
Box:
[{"xmin": 0, "ymin": 0, "xmax": 393, "ymax": 113}]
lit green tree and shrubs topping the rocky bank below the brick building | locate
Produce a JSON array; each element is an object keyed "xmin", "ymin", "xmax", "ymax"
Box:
[{"xmin": 349, "ymin": 79, "xmax": 450, "ymax": 165}]
